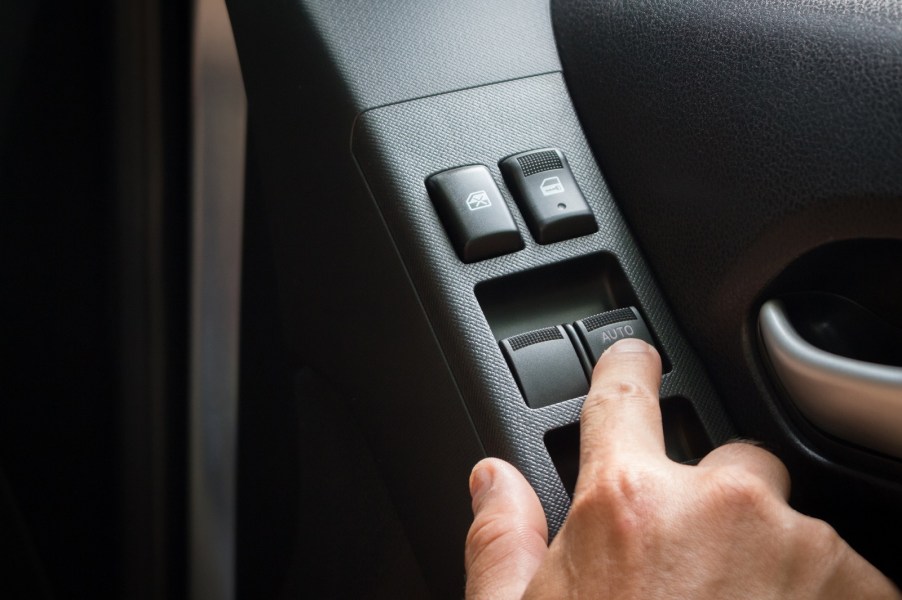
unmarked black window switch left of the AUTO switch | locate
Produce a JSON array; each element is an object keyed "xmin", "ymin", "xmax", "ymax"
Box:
[{"xmin": 501, "ymin": 325, "xmax": 589, "ymax": 408}]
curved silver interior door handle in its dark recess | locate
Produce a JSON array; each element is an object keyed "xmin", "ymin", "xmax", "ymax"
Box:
[{"xmin": 758, "ymin": 300, "xmax": 902, "ymax": 458}]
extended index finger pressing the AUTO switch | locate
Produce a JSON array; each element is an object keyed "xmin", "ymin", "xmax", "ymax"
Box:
[{"xmin": 579, "ymin": 338, "xmax": 665, "ymax": 472}]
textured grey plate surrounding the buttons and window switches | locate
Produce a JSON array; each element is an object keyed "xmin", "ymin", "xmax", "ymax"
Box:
[{"xmin": 353, "ymin": 74, "xmax": 733, "ymax": 535}]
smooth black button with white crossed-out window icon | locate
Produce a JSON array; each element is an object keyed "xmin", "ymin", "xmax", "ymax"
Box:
[{"xmin": 426, "ymin": 165, "xmax": 523, "ymax": 263}]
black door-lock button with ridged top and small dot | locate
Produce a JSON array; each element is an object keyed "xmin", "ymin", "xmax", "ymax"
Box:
[{"xmin": 500, "ymin": 148, "xmax": 598, "ymax": 244}]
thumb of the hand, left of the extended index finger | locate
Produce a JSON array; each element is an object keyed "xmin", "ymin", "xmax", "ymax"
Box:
[{"xmin": 465, "ymin": 458, "xmax": 548, "ymax": 600}]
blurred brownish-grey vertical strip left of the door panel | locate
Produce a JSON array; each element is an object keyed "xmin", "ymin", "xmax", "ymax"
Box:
[{"xmin": 188, "ymin": 0, "xmax": 247, "ymax": 600}]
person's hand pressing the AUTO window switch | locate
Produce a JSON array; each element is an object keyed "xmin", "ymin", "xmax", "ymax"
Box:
[{"xmin": 466, "ymin": 340, "xmax": 902, "ymax": 600}]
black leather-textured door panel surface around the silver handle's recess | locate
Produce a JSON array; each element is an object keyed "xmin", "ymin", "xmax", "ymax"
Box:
[{"xmin": 552, "ymin": 0, "xmax": 902, "ymax": 581}]
